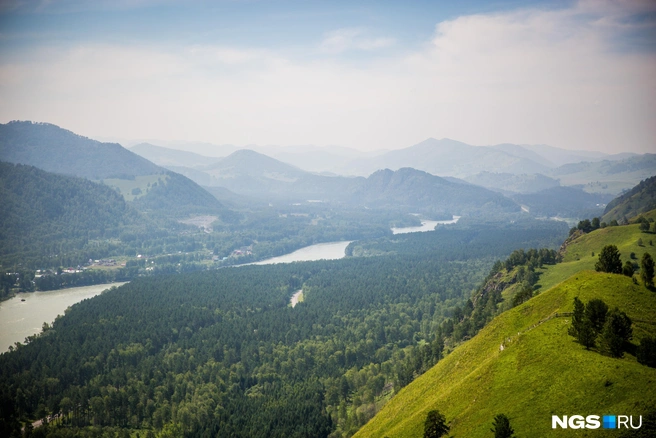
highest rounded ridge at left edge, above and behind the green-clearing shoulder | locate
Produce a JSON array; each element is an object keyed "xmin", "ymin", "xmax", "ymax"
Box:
[{"xmin": 0, "ymin": 122, "xmax": 162, "ymax": 180}]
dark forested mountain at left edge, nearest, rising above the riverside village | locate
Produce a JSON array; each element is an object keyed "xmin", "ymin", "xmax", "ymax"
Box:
[{"xmin": 0, "ymin": 162, "xmax": 150, "ymax": 266}]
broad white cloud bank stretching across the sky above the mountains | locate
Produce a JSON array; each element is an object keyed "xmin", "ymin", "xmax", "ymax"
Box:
[{"xmin": 0, "ymin": 3, "xmax": 656, "ymax": 152}]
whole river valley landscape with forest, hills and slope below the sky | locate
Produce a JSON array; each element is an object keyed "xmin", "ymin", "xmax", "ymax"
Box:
[{"xmin": 0, "ymin": 117, "xmax": 656, "ymax": 438}]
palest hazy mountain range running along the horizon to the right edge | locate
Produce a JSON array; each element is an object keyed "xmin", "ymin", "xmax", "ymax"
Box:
[{"xmin": 133, "ymin": 138, "xmax": 656, "ymax": 195}]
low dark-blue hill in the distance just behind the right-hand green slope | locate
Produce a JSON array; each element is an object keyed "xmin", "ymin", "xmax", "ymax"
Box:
[{"xmin": 511, "ymin": 187, "xmax": 613, "ymax": 219}]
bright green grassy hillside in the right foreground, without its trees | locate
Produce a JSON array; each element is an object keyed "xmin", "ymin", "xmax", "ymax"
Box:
[{"xmin": 356, "ymin": 217, "xmax": 656, "ymax": 438}]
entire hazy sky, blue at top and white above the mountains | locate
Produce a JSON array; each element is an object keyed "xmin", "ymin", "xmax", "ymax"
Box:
[{"xmin": 0, "ymin": 0, "xmax": 656, "ymax": 153}]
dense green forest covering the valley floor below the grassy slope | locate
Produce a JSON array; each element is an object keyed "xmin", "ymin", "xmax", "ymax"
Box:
[{"xmin": 0, "ymin": 222, "xmax": 560, "ymax": 437}]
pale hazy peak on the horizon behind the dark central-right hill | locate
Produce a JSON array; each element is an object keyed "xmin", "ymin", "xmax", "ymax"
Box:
[{"xmin": 344, "ymin": 138, "xmax": 549, "ymax": 178}]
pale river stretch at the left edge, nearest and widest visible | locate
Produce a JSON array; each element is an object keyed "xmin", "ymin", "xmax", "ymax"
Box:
[{"xmin": 0, "ymin": 283, "xmax": 125, "ymax": 353}]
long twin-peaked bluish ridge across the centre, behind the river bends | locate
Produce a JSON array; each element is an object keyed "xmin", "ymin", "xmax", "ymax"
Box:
[{"xmin": 168, "ymin": 150, "xmax": 519, "ymax": 216}]
